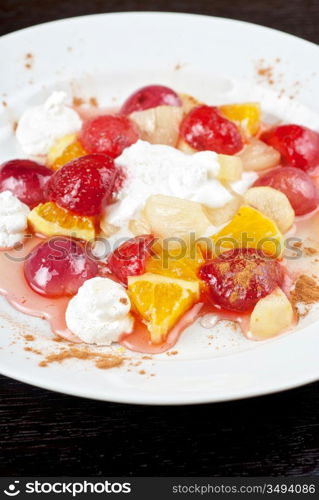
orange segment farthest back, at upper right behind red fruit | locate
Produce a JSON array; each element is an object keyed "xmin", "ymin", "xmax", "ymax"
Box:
[{"xmin": 219, "ymin": 102, "xmax": 260, "ymax": 138}]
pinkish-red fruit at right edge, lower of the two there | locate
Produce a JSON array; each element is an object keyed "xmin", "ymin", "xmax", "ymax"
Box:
[{"xmin": 254, "ymin": 167, "xmax": 319, "ymax": 215}]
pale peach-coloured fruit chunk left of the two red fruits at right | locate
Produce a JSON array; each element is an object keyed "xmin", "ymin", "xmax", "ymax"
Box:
[{"xmin": 238, "ymin": 137, "xmax": 280, "ymax": 172}]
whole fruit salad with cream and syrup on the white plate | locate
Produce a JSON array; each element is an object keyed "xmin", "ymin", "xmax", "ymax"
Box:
[{"xmin": 0, "ymin": 85, "xmax": 319, "ymax": 353}]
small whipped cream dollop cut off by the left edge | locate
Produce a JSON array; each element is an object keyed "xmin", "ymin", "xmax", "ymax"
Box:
[{"xmin": 0, "ymin": 191, "xmax": 30, "ymax": 248}]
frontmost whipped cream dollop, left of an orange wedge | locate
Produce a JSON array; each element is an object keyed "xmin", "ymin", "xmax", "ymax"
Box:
[{"xmin": 65, "ymin": 277, "xmax": 134, "ymax": 345}]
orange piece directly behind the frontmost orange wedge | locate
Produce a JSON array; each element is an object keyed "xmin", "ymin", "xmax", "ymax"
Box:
[{"xmin": 145, "ymin": 244, "xmax": 204, "ymax": 281}]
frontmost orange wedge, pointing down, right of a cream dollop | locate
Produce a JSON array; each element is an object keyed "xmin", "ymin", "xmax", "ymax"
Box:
[{"xmin": 128, "ymin": 273, "xmax": 199, "ymax": 344}]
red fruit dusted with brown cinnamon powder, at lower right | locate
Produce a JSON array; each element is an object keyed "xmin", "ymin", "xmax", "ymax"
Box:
[{"xmin": 199, "ymin": 248, "xmax": 284, "ymax": 312}]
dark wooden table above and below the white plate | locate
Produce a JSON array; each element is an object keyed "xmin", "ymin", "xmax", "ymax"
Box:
[{"xmin": 0, "ymin": 0, "xmax": 319, "ymax": 476}]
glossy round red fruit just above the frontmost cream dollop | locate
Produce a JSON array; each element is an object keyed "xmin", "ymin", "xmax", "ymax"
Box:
[{"xmin": 24, "ymin": 236, "xmax": 98, "ymax": 297}]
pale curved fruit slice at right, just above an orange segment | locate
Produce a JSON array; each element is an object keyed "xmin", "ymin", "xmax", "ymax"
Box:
[{"xmin": 244, "ymin": 186, "xmax": 295, "ymax": 233}]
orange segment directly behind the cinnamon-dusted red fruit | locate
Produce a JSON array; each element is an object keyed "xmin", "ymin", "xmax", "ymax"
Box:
[{"xmin": 211, "ymin": 206, "xmax": 284, "ymax": 258}]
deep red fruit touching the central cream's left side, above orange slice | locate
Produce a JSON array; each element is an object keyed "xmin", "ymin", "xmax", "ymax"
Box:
[{"xmin": 48, "ymin": 155, "xmax": 117, "ymax": 215}]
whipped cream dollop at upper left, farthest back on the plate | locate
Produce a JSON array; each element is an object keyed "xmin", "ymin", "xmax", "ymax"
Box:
[{"xmin": 16, "ymin": 91, "xmax": 82, "ymax": 156}]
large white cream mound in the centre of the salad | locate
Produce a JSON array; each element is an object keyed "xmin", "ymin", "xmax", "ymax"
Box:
[{"xmin": 107, "ymin": 140, "xmax": 253, "ymax": 226}]
